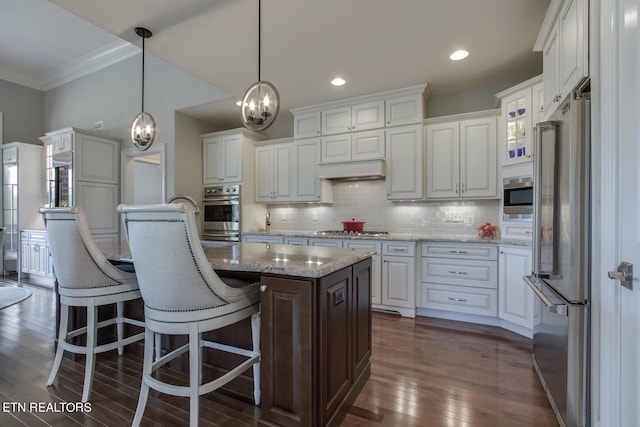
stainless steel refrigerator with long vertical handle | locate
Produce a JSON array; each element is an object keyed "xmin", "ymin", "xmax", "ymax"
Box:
[{"xmin": 524, "ymin": 94, "xmax": 590, "ymax": 427}]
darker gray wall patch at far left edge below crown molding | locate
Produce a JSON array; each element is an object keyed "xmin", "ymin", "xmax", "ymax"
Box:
[{"xmin": 0, "ymin": 80, "xmax": 44, "ymax": 144}]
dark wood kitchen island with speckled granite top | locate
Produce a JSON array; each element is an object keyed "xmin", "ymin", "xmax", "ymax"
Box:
[{"xmin": 106, "ymin": 242, "xmax": 374, "ymax": 426}]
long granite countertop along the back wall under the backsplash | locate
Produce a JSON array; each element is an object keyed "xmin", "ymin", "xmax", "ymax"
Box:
[{"xmin": 245, "ymin": 230, "xmax": 532, "ymax": 247}]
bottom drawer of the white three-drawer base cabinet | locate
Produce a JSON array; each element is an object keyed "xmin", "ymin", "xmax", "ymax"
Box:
[{"xmin": 421, "ymin": 283, "xmax": 498, "ymax": 317}]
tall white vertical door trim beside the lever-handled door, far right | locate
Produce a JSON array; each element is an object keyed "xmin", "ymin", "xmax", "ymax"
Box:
[{"xmin": 590, "ymin": 0, "xmax": 622, "ymax": 426}]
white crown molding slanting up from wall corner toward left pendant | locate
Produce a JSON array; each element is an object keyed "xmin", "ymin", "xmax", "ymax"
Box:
[{"xmin": 41, "ymin": 40, "xmax": 141, "ymax": 91}]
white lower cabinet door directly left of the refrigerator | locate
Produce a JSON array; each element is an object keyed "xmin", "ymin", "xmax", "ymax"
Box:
[{"xmin": 498, "ymin": 246, "xmax": 540, "ymax": 336}]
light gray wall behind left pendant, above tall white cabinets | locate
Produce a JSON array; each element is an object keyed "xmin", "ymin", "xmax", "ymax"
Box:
[{"xmin": 44, "ymin": 54, "xmax": 228, "ymax": 195}]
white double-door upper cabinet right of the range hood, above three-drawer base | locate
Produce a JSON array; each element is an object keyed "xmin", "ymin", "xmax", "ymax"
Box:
[{"xmin": 425, "ymin": 111, "xmax": 498, "ymax": 199}]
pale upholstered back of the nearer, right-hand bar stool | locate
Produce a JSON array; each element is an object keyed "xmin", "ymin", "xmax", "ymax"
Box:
[{"xmin": 118, "ymin": 203, "xmax": 256, "ymax": 321}]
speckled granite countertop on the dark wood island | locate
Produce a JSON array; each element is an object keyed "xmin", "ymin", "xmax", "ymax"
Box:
[{"xmin": 100, "ymin": 242, "xmax": 375, "ymax": 278}]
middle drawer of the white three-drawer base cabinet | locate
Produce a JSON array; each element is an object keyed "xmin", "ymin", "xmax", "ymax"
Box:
[{"xmin": 422, "ymin": 257, "xmax": 498, "ymax": 289}]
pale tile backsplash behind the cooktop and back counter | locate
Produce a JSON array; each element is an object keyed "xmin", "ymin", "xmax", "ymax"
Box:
[{"xmin": 268, "ymin": 180, "xmax": 500, "ymax": 236}]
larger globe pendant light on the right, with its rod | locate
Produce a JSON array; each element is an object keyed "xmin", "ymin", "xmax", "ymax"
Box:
[{"xmin": 240, "ymin": 0, "xmax": 280, "ymax": 131}]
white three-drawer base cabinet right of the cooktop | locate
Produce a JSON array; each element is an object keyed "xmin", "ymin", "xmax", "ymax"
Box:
[{"xmin": 419, "ymin": 243, "xmax": 498, "ymax": 317}]
